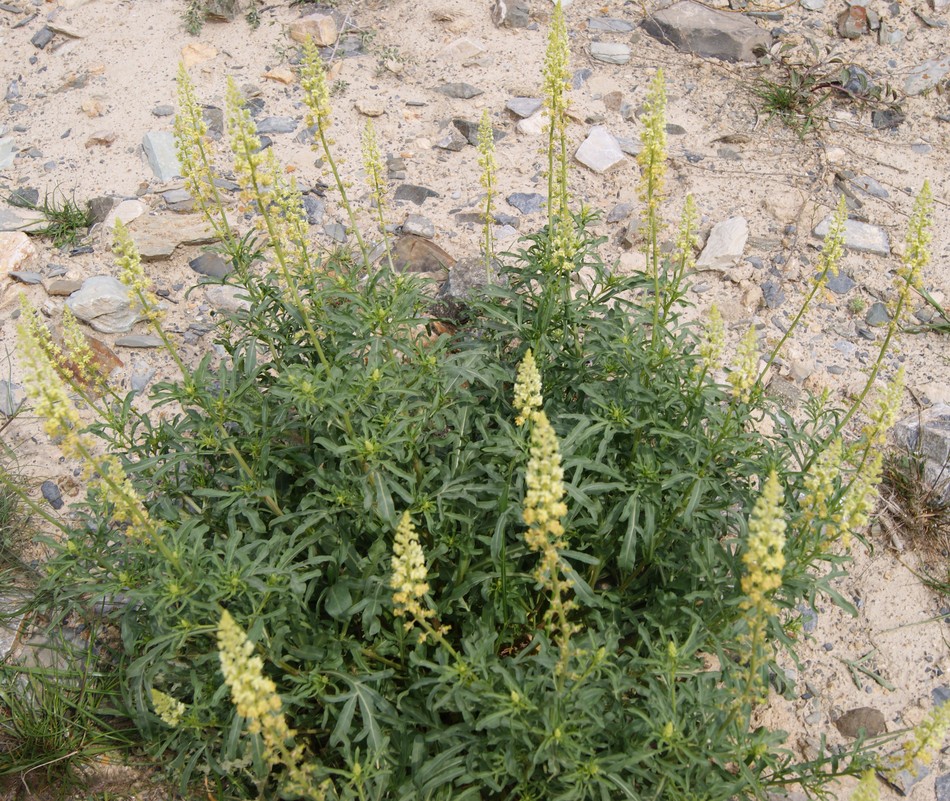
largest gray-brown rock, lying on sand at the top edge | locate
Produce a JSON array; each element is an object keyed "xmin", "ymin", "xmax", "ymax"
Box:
[{"xmin": 643, "ymin": 0, "xmax": 771, "ymax": 61}]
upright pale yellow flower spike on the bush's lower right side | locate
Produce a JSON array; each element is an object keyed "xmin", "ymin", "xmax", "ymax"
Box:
[{"xmin": 741, "ymin": 470, "xmax": 785, "ymax": 616}]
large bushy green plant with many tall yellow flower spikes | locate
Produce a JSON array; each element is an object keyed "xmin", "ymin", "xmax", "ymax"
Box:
[{"xmin": 9, "ymin": 7, "xmax": 944, "ymax": 801}]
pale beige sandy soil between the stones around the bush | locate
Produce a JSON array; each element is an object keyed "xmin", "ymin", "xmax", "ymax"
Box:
[{"xmin": 0, "ymin": 0, "xmax": 950, "ymax": 799}]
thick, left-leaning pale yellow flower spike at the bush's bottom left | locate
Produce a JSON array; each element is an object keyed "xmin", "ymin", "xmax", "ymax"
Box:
[{"xmin": 218, "ymin": 610, "xmax": 301, "ymax": 773}]
